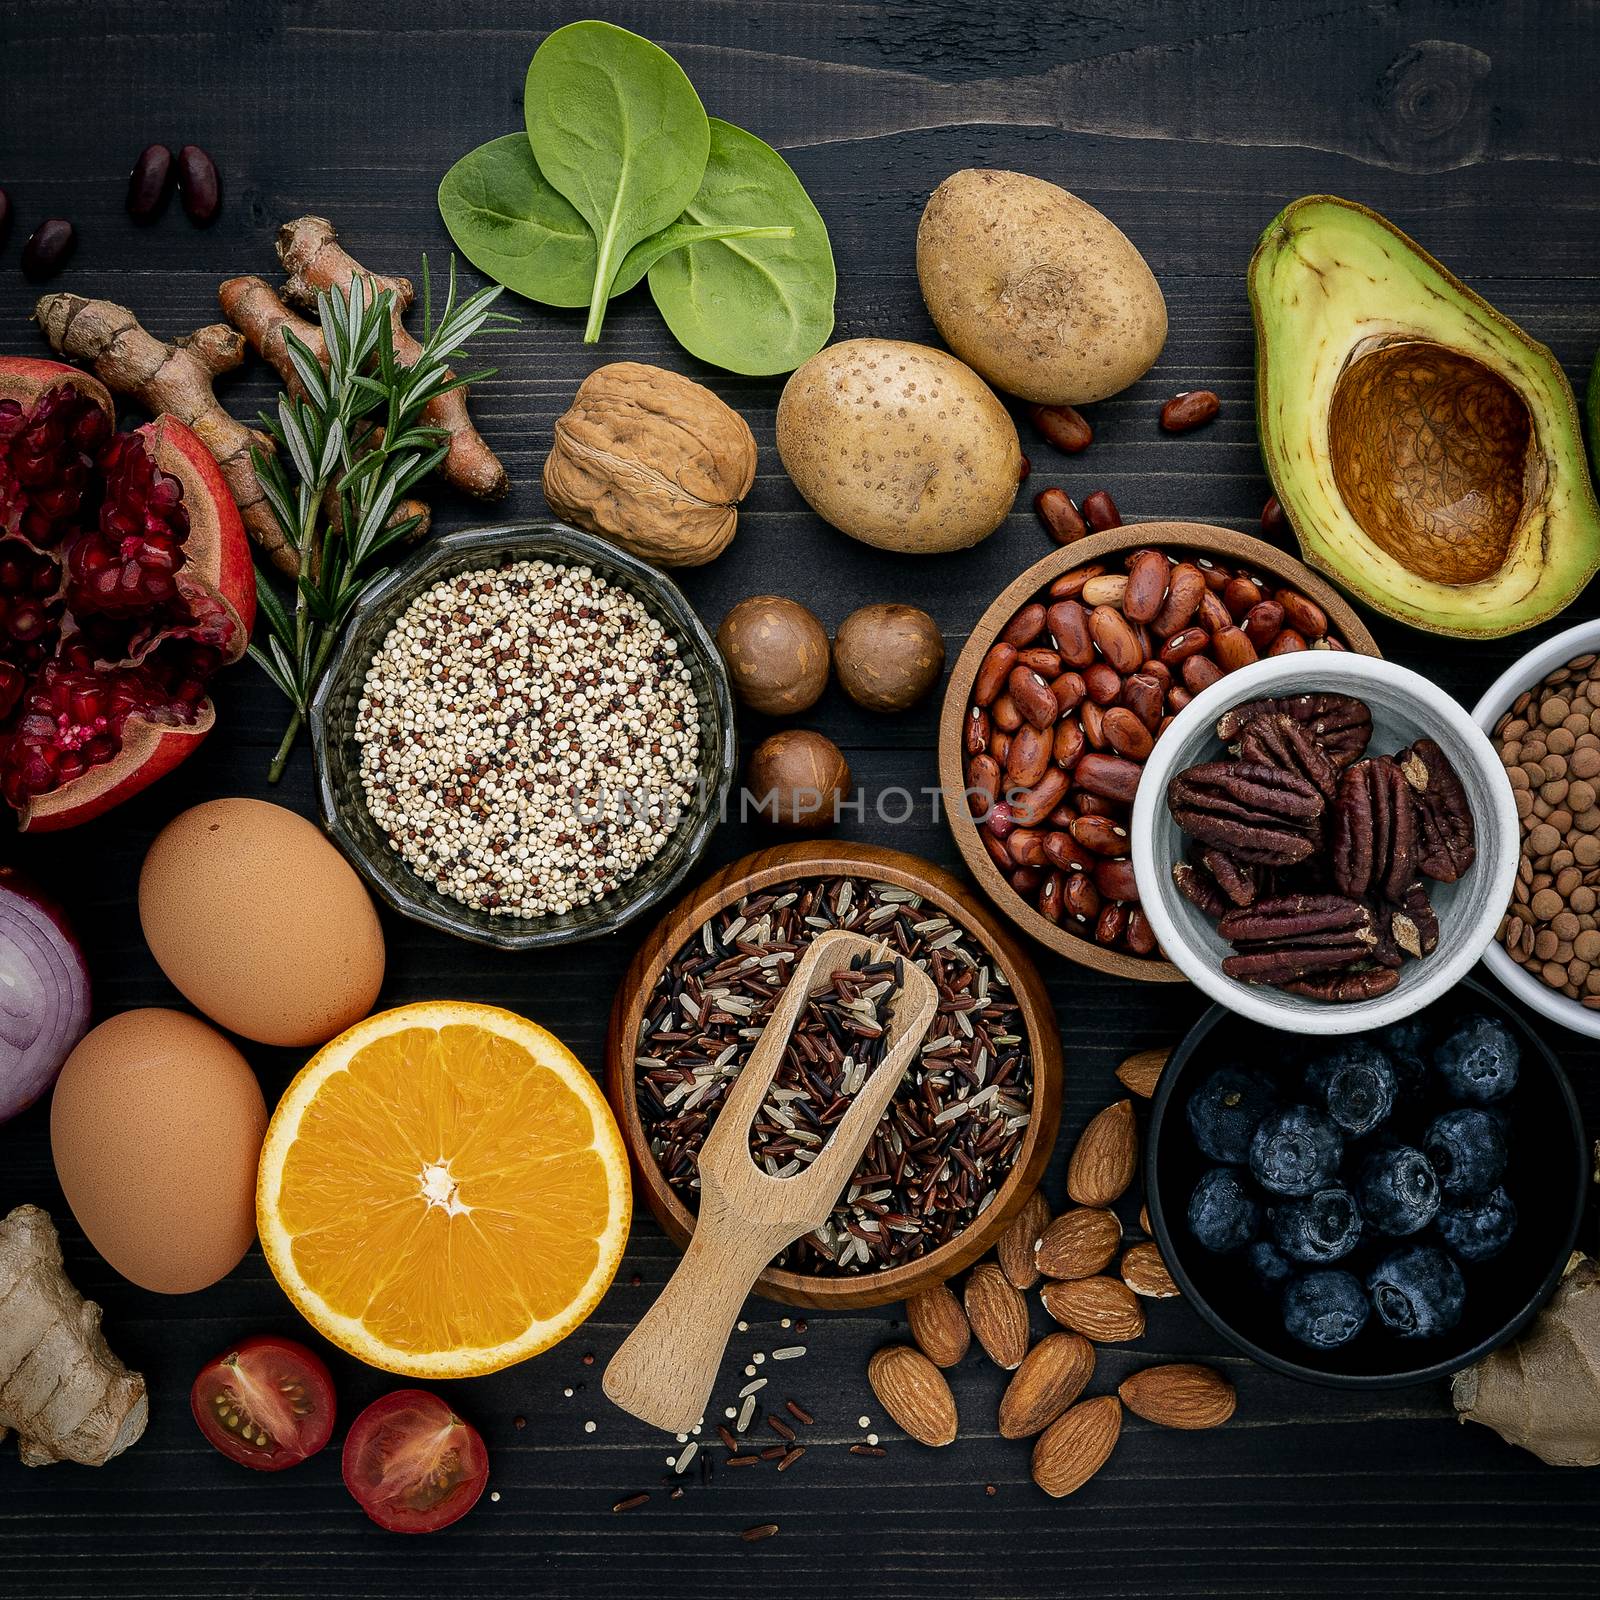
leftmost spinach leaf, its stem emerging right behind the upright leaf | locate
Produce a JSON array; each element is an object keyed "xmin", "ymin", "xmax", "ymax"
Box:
[{"xmin": 438, "ymin": 133, "xmax": 794, "ymax": 306}]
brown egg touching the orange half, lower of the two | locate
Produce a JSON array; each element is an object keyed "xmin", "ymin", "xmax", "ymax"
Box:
[{"xmin": 50, "ymin": 1008, "xmax": 267, "ymax": 1294}]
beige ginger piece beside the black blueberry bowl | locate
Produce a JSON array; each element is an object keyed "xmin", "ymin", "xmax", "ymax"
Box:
[{"xmin": 1450, "ymin": 1254, "xmax": 1600, "ymax": 1467}]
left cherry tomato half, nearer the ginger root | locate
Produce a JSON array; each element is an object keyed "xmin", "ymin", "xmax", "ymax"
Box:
[{"xmin": 189, "ymin": 1334, "xmax": 334, "ymax": 1472}]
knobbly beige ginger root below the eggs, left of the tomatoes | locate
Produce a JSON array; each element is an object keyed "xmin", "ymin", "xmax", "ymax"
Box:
[{"xmin": 0, "ymin": 1205, "xmax": 150, "ymax": 1467}]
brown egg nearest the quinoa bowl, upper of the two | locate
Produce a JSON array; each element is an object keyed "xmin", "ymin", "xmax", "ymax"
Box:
[{"xmin": 139, "ymin": 800, "xmax": 384, "ymax": 1045}]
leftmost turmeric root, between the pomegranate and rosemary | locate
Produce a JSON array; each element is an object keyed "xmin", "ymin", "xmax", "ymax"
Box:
[{"xmin": 34, "ymin": 294, "xmax": 296, "ymax": 573}]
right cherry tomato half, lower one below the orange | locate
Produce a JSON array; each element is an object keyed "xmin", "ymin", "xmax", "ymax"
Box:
[{"xmin": 344, "ymin": 1389, "xmax": 490, "ymax": 1533}]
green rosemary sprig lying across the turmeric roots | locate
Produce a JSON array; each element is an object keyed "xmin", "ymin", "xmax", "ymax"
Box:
[{"xmin": 250, "ymin": 256, "xmax": 514, "ymax": 782}]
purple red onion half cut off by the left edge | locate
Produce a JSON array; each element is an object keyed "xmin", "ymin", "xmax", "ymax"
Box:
[{"xmin": 0, "ymin": 867, "xmax": 90, "ymax": 1122}]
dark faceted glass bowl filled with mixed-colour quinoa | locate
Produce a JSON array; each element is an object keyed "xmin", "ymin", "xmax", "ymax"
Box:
[{"xmin": 312, "ymin": 523, "xmax": 736, "ymax": 950}]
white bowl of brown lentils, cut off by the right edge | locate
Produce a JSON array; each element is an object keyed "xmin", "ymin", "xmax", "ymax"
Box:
[{"xmin": 1472, "ymin": 621, "xmax": 1600, "ymax": 1038}]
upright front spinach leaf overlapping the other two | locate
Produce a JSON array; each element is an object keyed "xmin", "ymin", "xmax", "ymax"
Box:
[{"xmin": 523, "ymin": 22, "xmax": 710, "ymax": 344}]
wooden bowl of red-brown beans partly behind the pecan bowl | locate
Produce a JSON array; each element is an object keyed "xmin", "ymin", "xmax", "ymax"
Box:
[{"xmin": 939, "ymin": 522, "xmax": 1379, "ymax": 982}]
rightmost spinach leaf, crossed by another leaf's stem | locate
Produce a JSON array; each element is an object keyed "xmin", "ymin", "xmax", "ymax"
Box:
[{"xmin": 650, "ymin": 117, "xmax": 837, "ymax": 376}]
